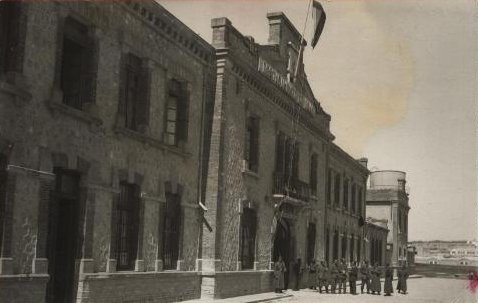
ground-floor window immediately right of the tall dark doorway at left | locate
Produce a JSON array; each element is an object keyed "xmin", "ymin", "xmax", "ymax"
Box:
[{"xmin": 116, "ymin": 182, "xmax": 140, "ymax": 271}]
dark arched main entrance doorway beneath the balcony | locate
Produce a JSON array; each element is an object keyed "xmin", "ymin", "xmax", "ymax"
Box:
[{"xmin": 272, "ymin": 218, "xmax": 292, "ymax": 289}]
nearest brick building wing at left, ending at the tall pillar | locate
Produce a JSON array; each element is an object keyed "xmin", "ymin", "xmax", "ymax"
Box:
[{"xmin": 0, "ymin": 1, "xmax": 215, "ymax": 302}]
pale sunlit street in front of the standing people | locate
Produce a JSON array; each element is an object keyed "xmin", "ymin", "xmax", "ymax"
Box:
[{"xmin": 269, "ymin": 278, "xmax": 478, "ymax": 303}]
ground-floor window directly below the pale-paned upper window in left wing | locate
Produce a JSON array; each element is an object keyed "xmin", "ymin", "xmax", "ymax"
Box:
[{"xmin": 163, "ymin": 193, "xmax": 181, "ymax": 269}]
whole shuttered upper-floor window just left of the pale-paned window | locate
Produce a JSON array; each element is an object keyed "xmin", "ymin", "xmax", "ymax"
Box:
[{"xmin": 120, "ymin": 53, "xmax": 150, "ymax": 132}]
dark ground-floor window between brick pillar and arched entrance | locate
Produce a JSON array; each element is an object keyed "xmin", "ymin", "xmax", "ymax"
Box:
[{"xmin": 241, "ymin": 208, "xmax": 257, "ymax": 269}]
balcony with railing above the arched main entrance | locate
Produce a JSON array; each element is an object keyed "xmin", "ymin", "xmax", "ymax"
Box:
[{"xmin": 272, "ymin": 173, "xmax": 310, "ymax": 204}]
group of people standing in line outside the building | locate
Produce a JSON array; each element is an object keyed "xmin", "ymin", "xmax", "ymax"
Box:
[{"xmin": 274, "ymin": 257, "xmax": 409, "ymax": 296}]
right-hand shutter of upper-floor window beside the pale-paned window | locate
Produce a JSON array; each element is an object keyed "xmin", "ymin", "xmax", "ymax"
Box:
[{"xmin": 135, "ymin": 59, "xmax": 151, "ymax": 126}]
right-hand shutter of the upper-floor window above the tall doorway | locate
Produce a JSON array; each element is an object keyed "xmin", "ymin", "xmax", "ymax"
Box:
[{"xmin": 81, "ymin": 37, "xmax": 99, "ymax": 104}]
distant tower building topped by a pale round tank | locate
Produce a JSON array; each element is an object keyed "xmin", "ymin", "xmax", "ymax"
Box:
[{"xmin": 367, "ymin": 170, "xmax": 410, "ymax": 266}]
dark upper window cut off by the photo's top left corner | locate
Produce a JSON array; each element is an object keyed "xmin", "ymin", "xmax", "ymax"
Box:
[{"xmin": 0, "ymin": 1, "xmax": 20, "ymax": 74}]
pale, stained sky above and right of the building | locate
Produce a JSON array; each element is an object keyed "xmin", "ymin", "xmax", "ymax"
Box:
[{"xmin": 158, "ymin": 0, "xmax": 478, "ymax": 240}]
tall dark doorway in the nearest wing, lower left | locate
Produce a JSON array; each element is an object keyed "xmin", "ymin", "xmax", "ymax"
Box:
[{"xmin": 46, "ymin": 169, "xmax": 80, "ymax": 303}]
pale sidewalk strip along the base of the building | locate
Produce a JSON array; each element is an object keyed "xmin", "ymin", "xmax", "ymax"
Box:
[{"xmin": 184, "ymin": 275, "xmax": 423, "ymax": 303}]
